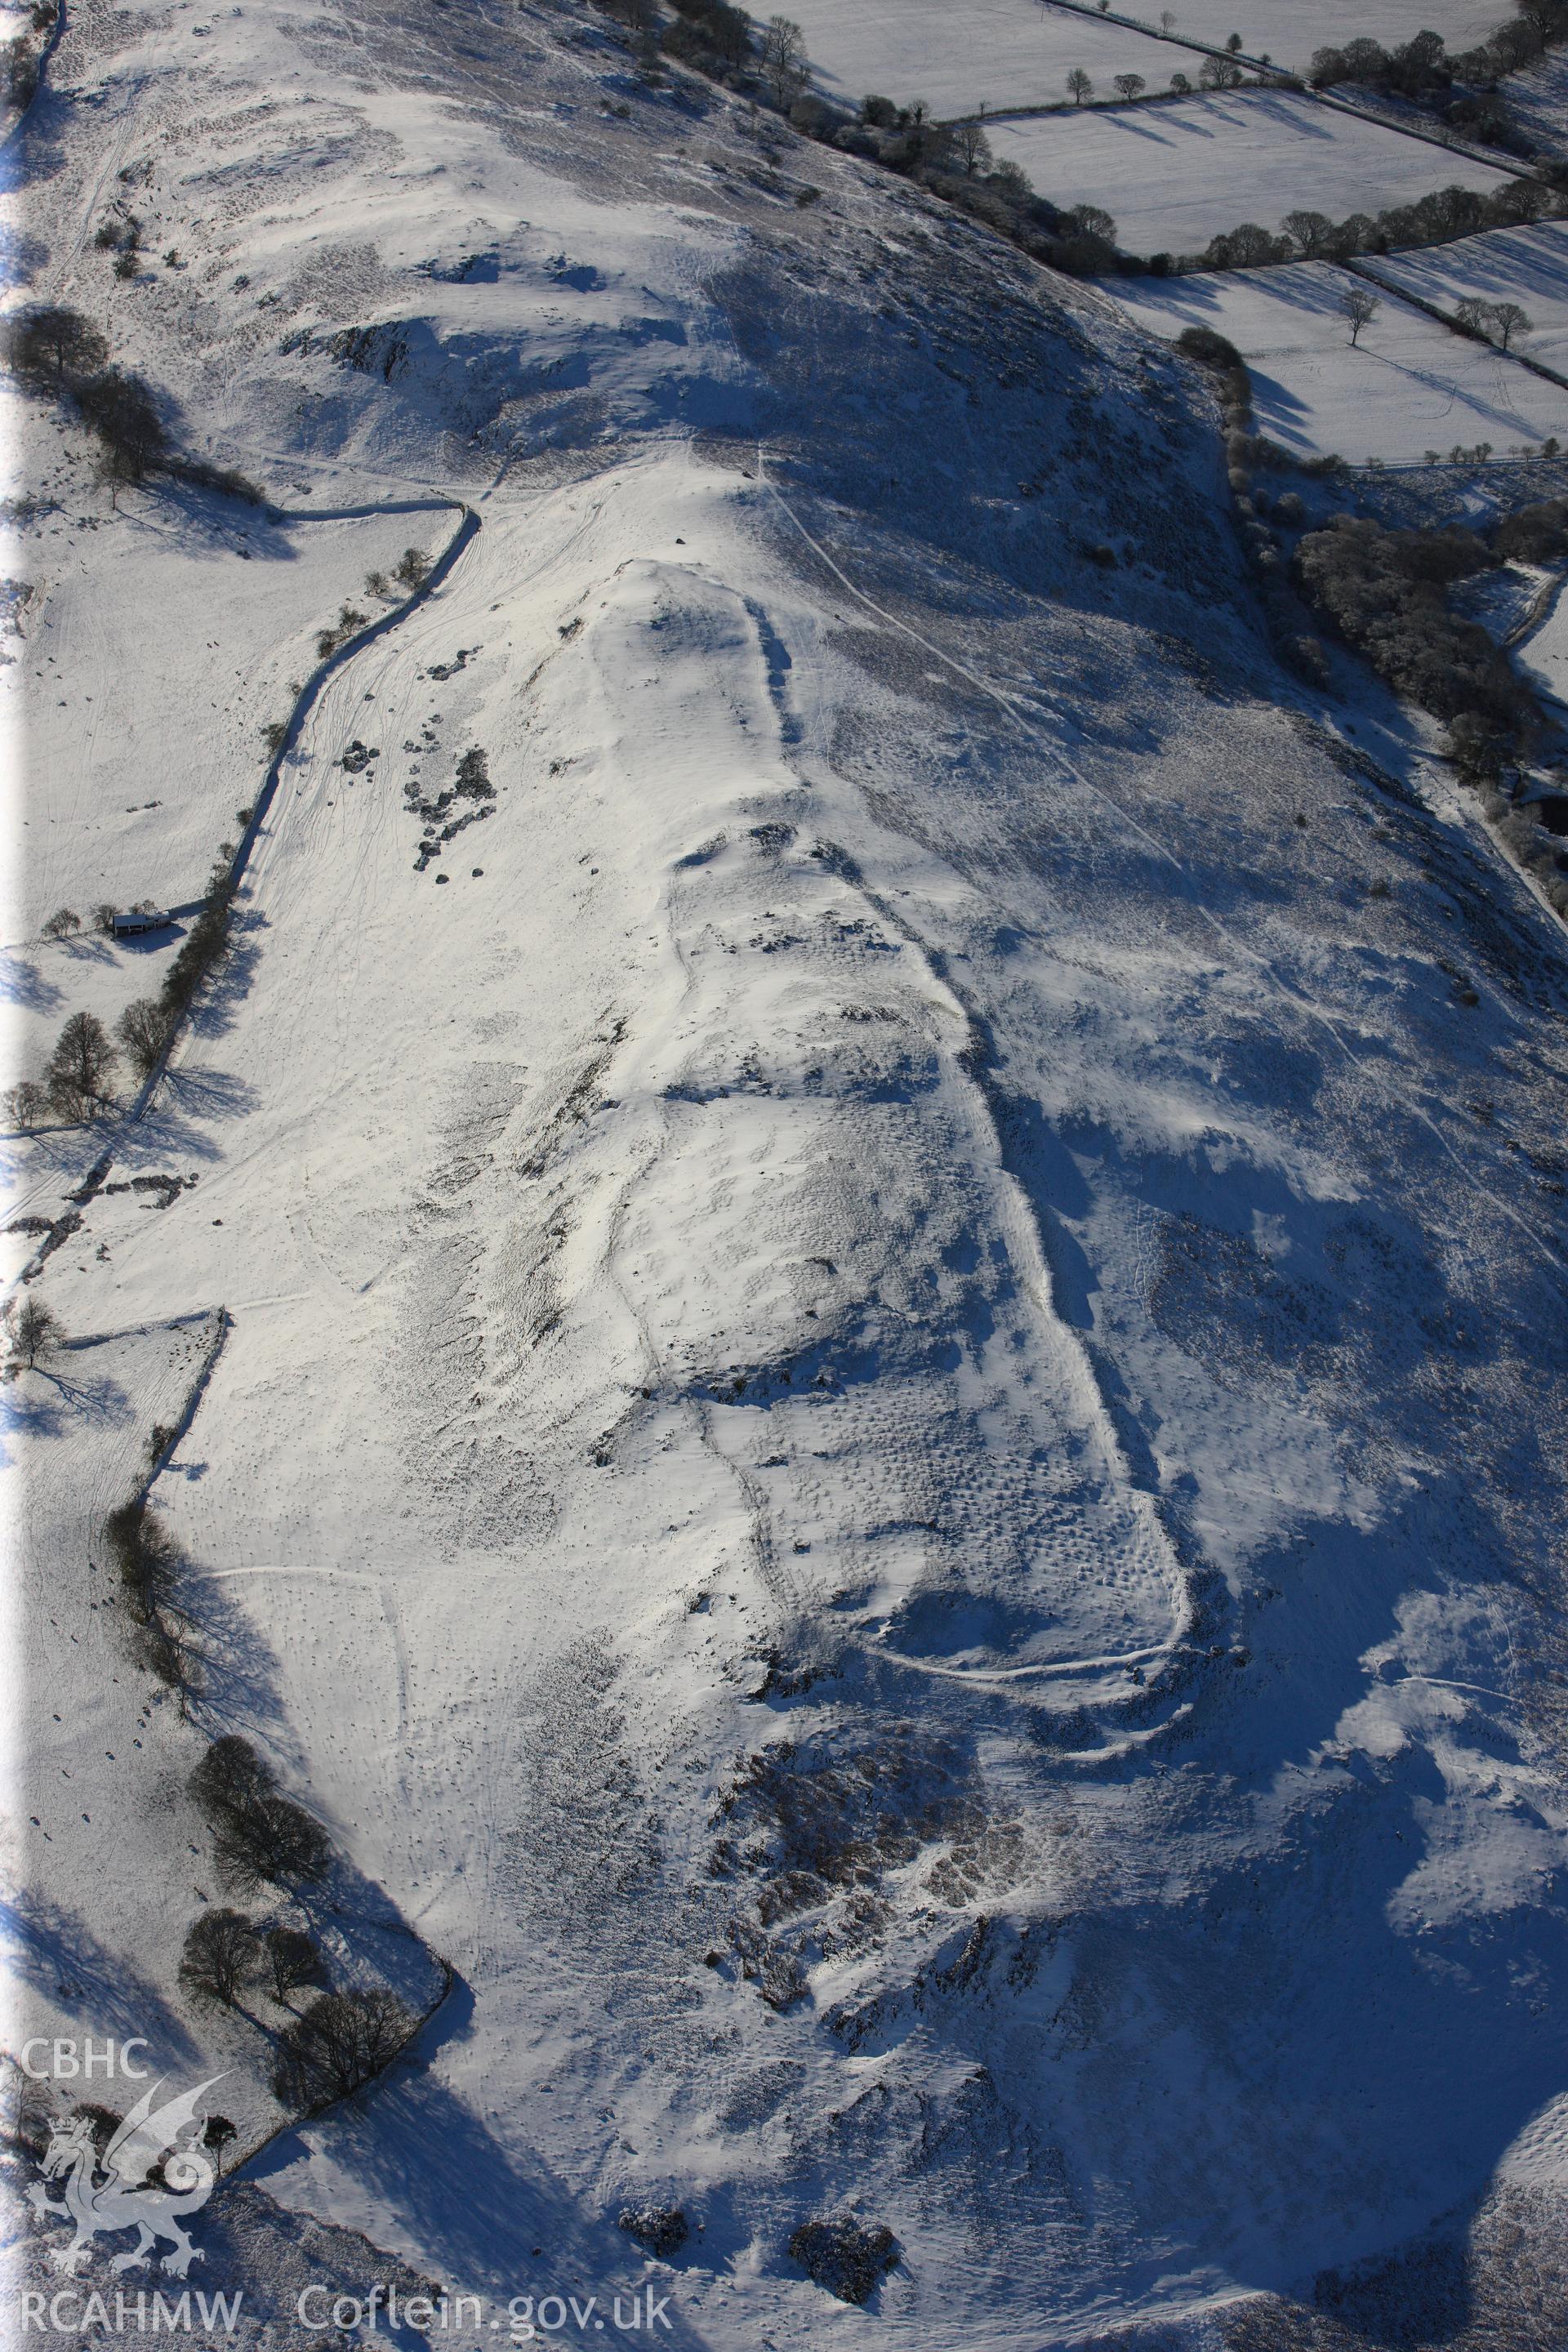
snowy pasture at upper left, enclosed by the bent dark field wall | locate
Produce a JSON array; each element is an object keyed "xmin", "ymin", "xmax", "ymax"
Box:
[{"xmin": 0, "ymin": 484, "xmax": 452, "ymax": 952}]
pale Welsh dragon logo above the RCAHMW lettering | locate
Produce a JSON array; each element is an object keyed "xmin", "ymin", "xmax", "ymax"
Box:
[{"xmin": 29, "ymin": 2074, "xmax": 223, "ymax": 2279}]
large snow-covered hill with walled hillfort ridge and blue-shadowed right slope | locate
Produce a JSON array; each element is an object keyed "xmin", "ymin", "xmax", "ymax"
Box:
[{"xmin": 7, "ymin": 0, "xmax": 1568, "ymax": 2352}]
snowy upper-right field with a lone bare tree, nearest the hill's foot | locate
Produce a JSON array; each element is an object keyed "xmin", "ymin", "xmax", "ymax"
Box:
[{"xmin": 1116, "ymin": 261, "xmax": 1568, "ymax": 466}]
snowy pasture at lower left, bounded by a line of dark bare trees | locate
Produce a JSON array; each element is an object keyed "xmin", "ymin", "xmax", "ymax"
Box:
[{"xmin": 0, "ymin": 1307, "xmax": 442, "ymax": 2154}]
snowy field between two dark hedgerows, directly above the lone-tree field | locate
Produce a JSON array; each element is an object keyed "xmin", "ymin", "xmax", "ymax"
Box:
[{"xmin": 990, "ymin": 89, "xmax": 1502, "ymax": 254}]
